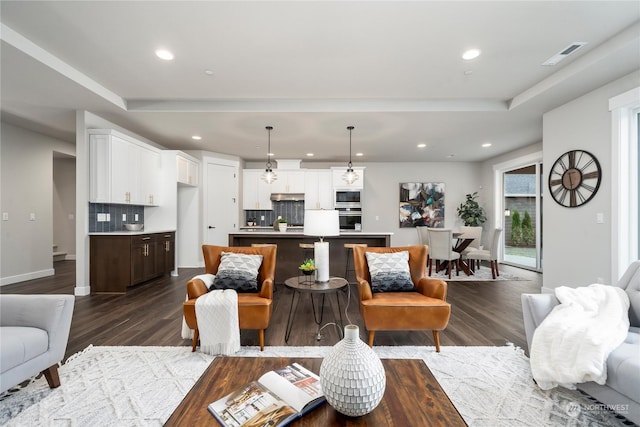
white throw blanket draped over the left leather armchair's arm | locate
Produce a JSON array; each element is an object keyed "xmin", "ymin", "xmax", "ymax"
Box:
[{"xmin": 182, "ymin": 274, "xmax": 240, "ymax": 355}]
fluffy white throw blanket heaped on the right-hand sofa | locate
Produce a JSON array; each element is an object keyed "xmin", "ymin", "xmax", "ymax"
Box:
[{"xmin": 530, "ymin": 284, "xmax": 629, "ymax": 390}]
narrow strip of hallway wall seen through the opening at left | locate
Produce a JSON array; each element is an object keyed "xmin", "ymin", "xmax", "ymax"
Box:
[{"xmin": 53, "ymin": 156, "xmax": 76, "ymax": 259}]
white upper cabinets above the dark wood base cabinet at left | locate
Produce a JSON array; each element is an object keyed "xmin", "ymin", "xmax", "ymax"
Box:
[{"xmin": 89, "ymin": 129, "xmax": 160, "ymax": 206}]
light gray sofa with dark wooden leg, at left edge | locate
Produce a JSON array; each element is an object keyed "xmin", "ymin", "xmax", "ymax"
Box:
[{"xmin": 0, "ymin": 294, "xmax": 75, "ymax": 393}]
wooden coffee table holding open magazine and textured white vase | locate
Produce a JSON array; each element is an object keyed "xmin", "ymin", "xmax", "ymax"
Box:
[{"xmin": 165, "ymin": 357, "xmax": 467, "ymax": 427}]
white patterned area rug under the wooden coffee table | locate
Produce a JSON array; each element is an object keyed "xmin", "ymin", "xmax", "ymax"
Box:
[{"xmin": 0, "ymin": 346, "xmax": 624, "ymax": 427}]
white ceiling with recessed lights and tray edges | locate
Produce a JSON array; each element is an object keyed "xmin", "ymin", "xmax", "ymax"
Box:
[{"xmin": 0, "ymin": 0, "xmax": 640, "ymax": 162}]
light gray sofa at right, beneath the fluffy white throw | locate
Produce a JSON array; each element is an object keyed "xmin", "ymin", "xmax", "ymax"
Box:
[{"xmin": 522, "ymin": 261, "xmax": 640, "ymax": 425}]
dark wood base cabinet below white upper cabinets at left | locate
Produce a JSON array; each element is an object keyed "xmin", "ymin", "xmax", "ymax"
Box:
[{"xmin": 90, "ymin": 232, "xmax": 176, "ymax": 293}]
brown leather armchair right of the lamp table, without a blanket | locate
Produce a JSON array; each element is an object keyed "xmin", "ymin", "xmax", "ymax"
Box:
[{"xmin": 353, "ymin": 245, "xmax": 451, "ymax": 352}]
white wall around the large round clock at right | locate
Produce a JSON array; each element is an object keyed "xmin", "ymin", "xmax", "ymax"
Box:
[{"xmin": 543, "ymin": 72, "xmax": 640, "ymax": 289}]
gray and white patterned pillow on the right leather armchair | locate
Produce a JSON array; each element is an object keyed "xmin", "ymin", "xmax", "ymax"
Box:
[{"xmin": 365, "ymin": 251, "xmax": 416, "ymax": 292}]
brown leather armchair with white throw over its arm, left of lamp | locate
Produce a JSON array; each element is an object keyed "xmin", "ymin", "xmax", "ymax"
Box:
[{"xmin": 183, "ymin": 245, "xmax": 277, "ymax": 351}]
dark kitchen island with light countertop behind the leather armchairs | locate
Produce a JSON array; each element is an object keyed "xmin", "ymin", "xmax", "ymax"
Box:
[{"xmin": 229, "ymin": 230, "xmax": 393, "ymax": 283}]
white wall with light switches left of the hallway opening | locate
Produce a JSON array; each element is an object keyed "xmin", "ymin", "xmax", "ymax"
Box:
[{"xmin": 0, "ymin": 122, "xmax": 75, "ymax": 285}]
